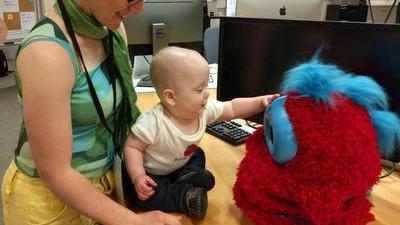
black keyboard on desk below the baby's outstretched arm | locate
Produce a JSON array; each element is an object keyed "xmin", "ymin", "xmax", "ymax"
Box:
[{"xmin": 206, "ymin": 121, "xmax": 250, "ymax": 145}]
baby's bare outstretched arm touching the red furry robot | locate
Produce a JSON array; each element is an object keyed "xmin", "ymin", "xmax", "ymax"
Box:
[{"xmin": 218, "ymin": 94, "xmax": 280, "ymax": 121}]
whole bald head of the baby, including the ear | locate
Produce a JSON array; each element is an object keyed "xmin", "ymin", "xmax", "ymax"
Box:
[{"xmin": 150, "ymin": 47, "xmax": 210, "ymax": 118}]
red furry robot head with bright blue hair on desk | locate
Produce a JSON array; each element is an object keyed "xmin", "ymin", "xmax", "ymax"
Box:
[{"xmin": 233, "ymin": 60, "xmax": 400, "ymax": 225}]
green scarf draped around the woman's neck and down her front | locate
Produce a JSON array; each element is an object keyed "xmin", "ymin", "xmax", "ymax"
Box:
[{"xmin": 54, "ymin": 0, "xmax": 140, "ymax": 153}]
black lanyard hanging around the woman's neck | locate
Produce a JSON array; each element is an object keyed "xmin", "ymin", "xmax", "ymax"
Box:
[{"xmin": 57, "ymin": 0, "xmax": 119, "ymax": 150}]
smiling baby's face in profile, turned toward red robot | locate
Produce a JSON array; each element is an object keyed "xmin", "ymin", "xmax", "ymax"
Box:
[{"xmin": 171, "ymin": 59, "xmax": 209, "ymax": 119}]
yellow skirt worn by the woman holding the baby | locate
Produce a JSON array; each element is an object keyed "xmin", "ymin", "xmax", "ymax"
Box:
[{"xmin": 1, "ymin": 162, "xmax": 115, "ymax": 225}]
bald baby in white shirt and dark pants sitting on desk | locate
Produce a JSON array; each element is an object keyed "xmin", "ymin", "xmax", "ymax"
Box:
[{"xmin": 122, "ymin": 47, "xmax": 279, "ymax": 219}]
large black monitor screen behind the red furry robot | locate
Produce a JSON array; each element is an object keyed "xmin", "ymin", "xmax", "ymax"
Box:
[{"xmin": 217, "ymin": 18, "xmax": 400, "ymax": 123}]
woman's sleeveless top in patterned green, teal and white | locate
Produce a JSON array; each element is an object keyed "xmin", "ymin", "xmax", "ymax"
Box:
[{"xmin": 14, "ymin": 17, "xmax": 122, "ymax": 178}]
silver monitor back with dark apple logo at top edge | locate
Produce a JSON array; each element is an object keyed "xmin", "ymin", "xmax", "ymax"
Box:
[{"xmin": 236, "ymin": 0, "xmax": 327, "ymax": 20}]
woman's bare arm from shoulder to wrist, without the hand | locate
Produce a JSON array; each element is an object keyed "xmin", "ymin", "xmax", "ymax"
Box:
[{"xmin": 17, "ymin": 42, "xmax": 138, "ymax": 224}]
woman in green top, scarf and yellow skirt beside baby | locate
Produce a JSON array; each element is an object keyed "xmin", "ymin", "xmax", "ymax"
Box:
[{"xmin": 2, "ymin": 0, "xmax": 181, "ymax": 225}]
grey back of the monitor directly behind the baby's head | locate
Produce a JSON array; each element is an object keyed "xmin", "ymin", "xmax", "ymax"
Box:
[{"xmin": 124, "ymin": 0, "xmax": 203, "ymax": 55}]
